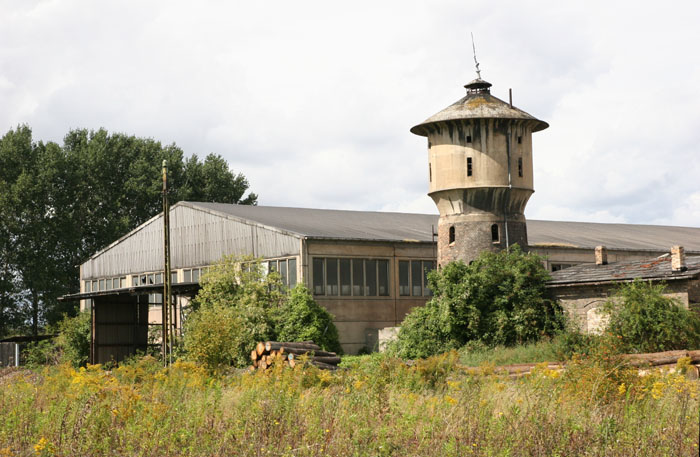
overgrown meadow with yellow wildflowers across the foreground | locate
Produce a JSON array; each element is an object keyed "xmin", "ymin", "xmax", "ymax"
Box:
[{"xmin": 0, "ymin": 352, "xmax": 700, "ymax": 457}]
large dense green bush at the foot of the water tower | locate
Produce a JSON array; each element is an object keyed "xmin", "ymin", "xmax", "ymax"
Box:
[{"xmin": 394, "ymin": 245, "xmax": 563, "ymax": 358}]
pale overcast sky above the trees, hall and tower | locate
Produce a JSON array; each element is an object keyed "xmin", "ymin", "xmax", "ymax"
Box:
[{"xmin": 0, "ymin": 0, "xmax": 700, "ymax": 227}]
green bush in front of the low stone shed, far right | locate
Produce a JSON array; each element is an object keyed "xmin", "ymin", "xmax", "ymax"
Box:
[{"xmin": 604, "ymin": 280, "xmax": 700, "ymax": 352}]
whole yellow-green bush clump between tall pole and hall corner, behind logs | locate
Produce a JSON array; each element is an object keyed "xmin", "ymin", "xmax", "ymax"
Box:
[{"xmin": 184, "ymin": 257, "xmax": 341, "ymax": 370}]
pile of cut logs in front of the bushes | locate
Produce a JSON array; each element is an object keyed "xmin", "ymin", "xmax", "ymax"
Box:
[{"xmin": 250, "ymin": 341, "xmax": 340, "ymax": 371}]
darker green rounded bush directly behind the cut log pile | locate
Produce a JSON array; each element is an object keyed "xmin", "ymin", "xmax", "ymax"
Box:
[{"xmin": 275, "ymin": 284, "xmax": 342, "ymax": 353}]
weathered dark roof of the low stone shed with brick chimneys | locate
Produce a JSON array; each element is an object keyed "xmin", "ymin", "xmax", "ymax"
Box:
[{"xmin": 547, "ymin": 255, "xmax": 700, "ymax": 287}]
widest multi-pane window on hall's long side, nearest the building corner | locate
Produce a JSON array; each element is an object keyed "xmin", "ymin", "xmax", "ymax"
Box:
[{"xmin": 313, "ymin": 257, "xmax": 390, "ymax": 297}]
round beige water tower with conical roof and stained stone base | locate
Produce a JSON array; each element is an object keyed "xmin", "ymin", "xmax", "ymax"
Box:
[{"xmin": 411, "ymin": 77, "xmax": 549, "ymax": 266}]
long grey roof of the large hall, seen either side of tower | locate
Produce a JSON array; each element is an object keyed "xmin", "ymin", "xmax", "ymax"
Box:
[{"xmin": 185, "ymin": 202, "xmax": 700, "ymax": 252}]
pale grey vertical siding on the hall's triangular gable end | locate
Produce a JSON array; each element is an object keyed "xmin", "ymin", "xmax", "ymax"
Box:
[{"xmin": 82, "ymin": 206, "xmax": 299, "ymax": 278}]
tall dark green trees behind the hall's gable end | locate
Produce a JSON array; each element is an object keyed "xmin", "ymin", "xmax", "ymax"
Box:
[{"xmin": 0, "ymin": 126, "xmax": 257, "ymax": 334}]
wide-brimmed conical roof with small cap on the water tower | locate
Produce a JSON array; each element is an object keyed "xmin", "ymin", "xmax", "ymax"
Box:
[{"xmin": 411, "ymin": 78, "xmax": 549, "ymax": 136}]
